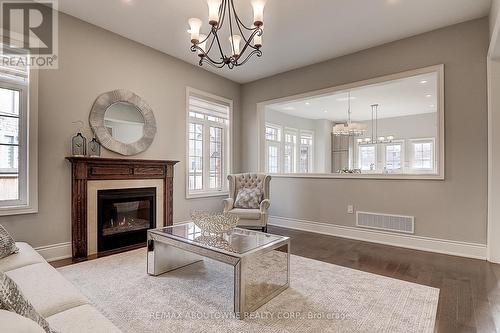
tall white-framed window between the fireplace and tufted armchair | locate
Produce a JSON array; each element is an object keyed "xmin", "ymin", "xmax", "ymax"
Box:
[{"xmin": 187, "ymin": 89, "xmax": 231, "ymax": 197}]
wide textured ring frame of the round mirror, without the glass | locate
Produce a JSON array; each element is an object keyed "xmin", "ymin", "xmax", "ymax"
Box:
[{"xmin": 89, "ymin": 89, "xmax": 156, "ymax": 156}]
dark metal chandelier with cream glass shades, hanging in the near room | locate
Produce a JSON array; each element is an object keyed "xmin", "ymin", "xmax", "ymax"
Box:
[{"xmin": 188, "ymin": 0, "xmax": 265, "ymax": 69}]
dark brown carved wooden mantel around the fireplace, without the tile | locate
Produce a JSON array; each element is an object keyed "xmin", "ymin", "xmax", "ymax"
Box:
[{"xmin": 66, "ymin": 156, "xmax": 178, "ymax": 258}]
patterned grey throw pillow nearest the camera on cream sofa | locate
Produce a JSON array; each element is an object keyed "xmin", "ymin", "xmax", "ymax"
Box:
[{"xmin": 0, "ymin": 272, "xmax": 56, "ymax": 333}]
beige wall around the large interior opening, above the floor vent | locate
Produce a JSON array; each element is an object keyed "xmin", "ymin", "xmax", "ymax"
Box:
[{"xmin": 242, "ymin": 18, "xmax": 489, "ymax": 244}]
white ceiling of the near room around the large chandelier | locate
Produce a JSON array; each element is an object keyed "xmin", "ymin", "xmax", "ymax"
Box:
[{"xmin": 59, "ymin": 0, "xmax": 491, "ymax": 83}]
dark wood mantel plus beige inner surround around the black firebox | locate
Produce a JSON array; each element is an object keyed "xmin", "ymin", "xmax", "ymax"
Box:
[{"xmin": 67, "ymin": 157, "xmax": 178, "ymax": 258}]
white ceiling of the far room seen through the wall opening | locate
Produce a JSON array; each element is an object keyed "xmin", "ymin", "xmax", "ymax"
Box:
[{"xmin": 267, "ymin": 73, "xmax": 438, "ymax": 122}]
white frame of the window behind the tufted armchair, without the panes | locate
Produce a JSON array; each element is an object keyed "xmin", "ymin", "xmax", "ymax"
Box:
[{"xmin": 185, "ymin": 87, "xmax": 233, "ymax": 199}]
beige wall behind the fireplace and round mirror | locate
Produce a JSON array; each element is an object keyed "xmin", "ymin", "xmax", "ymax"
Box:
[{"xmin": 0, "ymin": 14, "xmax": 240, "ymax": 246}]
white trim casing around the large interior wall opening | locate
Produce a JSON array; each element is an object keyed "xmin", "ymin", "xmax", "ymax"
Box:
[{"xmin": 257, "ymin": 64, "xmax": 445, "ymax": 180}]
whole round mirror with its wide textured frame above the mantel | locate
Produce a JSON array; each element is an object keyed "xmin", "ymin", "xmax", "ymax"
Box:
[{"xmin": 89, "ymin": 90, "xmax": 156, "ymax": 156}]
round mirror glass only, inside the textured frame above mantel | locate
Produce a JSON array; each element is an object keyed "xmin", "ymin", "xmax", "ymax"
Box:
[{"xmin": 104, "ymin": 102, "xmax": 145, "ymax": 144}]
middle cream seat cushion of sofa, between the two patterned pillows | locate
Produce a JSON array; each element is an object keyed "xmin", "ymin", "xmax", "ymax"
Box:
[{"xmin": 6, "ymin": 263, "xmax": 88, "ymax": 317}]
